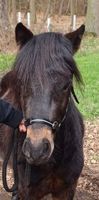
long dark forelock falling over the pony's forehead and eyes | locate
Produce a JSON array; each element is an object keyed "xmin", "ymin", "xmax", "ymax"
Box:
[{"xmin": 13, "ymin": 33, "xmax": 82, "ymax": 93}]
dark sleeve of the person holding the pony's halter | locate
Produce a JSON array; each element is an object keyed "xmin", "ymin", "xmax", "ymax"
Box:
[{"xmin": 0, "ymin": 99, "xmax": 23, "ymax": 128}]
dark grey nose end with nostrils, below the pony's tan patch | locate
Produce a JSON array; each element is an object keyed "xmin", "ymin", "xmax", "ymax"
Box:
[{"xmin": 22, "ymin": 138, "xmax": 51, "ymax": 165}]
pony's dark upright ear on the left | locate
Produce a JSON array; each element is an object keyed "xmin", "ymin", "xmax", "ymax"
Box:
[{"xmin": 15, "ymin": 23, "xmax": 33, "ymax": 48}]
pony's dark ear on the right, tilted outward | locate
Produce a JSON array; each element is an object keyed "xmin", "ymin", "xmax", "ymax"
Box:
[{"xmin": 65, "ymin": 24, "xmax": 85, "ymax": 53}]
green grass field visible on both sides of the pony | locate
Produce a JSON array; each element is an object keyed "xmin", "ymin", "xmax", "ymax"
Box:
[{"xmin": 0, "ymin": 37, "xmax": 99, "ymax": 119}]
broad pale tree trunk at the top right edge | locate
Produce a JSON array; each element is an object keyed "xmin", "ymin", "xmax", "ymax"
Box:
[{"xmin": 86, "ymin": 0, "xmax": 99, "ymax": 36}]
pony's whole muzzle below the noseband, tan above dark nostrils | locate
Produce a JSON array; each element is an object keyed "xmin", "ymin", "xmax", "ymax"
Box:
[{"xmin": 22, "ymin": 124, "xmax": 54, "ymax": 165}]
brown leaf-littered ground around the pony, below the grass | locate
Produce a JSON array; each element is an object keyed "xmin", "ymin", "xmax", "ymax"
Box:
[{"xmin": 0, "ymin": 119, "xmax": 99, "ymax": 200}]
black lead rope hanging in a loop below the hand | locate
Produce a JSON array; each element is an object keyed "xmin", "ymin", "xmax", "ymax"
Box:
[{"xmin": 2, "ymin": 129, "xmax": 18, "ymax": 192}]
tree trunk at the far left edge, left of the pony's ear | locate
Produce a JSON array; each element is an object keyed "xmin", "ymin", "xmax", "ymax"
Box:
[{"xmin": 0, "ymin": 0, "xmax": 10, "ymax": 51}]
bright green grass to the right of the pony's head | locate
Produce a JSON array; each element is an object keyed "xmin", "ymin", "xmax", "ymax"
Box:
[{"xmin": 76, "ymin": 52, "xmax": 99, "ymax": 119}]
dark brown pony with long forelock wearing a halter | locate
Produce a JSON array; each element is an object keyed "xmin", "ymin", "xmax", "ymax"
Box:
[{"xmin": 0, "ymin": 23, "xmax": 85, "ymax": 200}]
